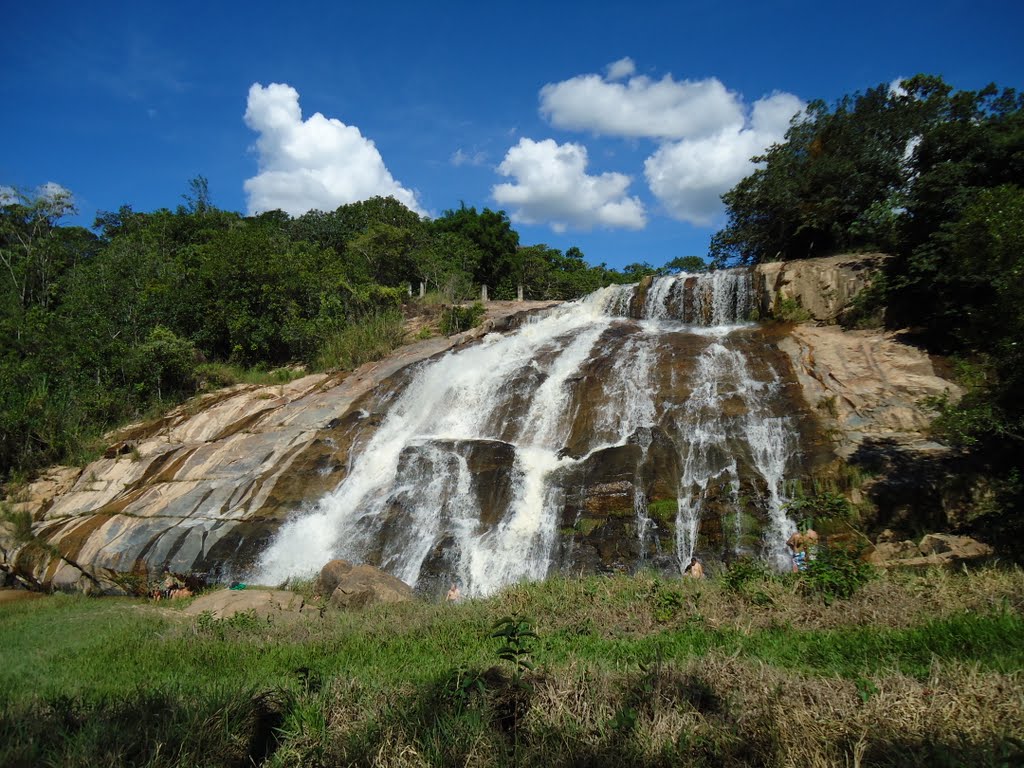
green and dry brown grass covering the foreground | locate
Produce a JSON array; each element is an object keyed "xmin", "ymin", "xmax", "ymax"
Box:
[{"xmin": 0, "ymin": 567, "xmax": 1024, "ymax": 768}]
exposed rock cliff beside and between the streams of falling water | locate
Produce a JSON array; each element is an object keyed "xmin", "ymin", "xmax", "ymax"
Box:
[{"xmin": 0, "ymin": 254, "xmax": 959, "ymax": 592}]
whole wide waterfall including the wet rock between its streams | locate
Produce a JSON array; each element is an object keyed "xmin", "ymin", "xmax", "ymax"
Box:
[{"xmin": 254, "ymin": 270, "xmax": 795, "ymax": 595}]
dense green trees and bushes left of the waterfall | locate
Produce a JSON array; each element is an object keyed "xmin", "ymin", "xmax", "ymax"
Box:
[{"xmin": 0, "ymin": 187, "xmax": 653, "ymax": 478}]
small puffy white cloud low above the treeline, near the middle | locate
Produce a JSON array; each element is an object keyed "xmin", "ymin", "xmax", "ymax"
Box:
[{"xmin": 492, "ymin": 138, "xmax": 647, "ymax": 232}]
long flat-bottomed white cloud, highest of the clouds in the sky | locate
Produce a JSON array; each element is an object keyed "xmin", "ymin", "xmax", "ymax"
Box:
[{"xmin": 541, "ymin": 66, "xmax": 743, "ymax": 139}]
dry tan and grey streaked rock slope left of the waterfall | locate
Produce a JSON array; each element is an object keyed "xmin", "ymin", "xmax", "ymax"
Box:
[{"xmin": 0, "ymin": 301, "xmax": 557, "ymax": 593}]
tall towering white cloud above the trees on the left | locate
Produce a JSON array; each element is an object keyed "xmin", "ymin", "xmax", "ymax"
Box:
[{"xmin": 245, "ymin": 83, "xmax": 423, "ymax": 216}]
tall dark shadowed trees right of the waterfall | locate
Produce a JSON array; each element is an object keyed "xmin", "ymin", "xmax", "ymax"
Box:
[{"xmin": 712, "ymin": 75, "xmax": 1024, "ymax": 541}]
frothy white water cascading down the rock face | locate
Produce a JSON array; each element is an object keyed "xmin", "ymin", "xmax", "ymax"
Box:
[{"xmin": 255, "ymin": 270, "xmax": 792, "ymax": 595}]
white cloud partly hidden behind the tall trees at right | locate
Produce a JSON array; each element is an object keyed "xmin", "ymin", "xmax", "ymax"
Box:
[{"xmin": 644, "ymin": 93, "xmax": 804, "ymax": 226}]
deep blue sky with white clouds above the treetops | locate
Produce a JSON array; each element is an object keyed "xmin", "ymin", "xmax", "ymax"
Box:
[{"xmin": 0, "ymin": 0, "xmax": 1024, "ymax": 267}]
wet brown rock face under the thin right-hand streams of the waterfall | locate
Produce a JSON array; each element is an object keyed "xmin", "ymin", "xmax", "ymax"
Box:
[{"xmin": 544, "ymin": 325, "xmax": 830, "ymax": 573}]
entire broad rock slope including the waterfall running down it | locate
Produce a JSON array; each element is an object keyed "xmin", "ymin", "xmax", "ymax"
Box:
[{"xmin": 0, "ymin": 255, "xmax": 958, "ymax": 602}]
